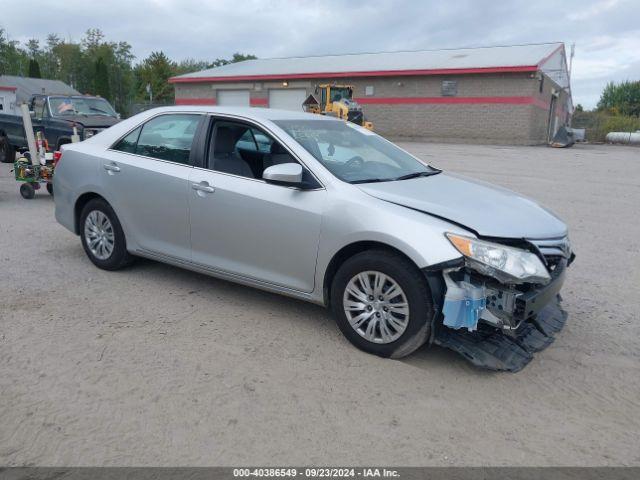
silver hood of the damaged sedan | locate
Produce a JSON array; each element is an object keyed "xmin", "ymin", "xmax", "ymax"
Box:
[{"xmin": 357, "ymin": 173, "xmax": 567, "ymax": 239}]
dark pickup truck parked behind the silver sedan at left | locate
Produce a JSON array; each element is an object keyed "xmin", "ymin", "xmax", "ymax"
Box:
[{"xmin": 0, "ymin": 95, "xmax": 120, "ymax": 163}]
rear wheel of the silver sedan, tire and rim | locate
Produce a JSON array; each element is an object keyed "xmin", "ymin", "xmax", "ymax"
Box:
[{"xmin": 80, "ymin": 199, "xmax": 133, "ymax": 270}]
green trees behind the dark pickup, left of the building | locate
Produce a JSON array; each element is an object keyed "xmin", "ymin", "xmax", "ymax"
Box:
[{"xmin": 0, "ymin": 28, "xmax": 256, "ymax": 116}]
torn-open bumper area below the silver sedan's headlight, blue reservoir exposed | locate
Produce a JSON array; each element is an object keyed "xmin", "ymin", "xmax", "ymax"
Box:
[{"xmin": 433, "ymin": 254, "xmax": 574, "ymax": 372}]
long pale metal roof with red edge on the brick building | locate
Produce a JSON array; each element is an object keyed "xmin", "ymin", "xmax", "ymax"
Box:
[{"xmin": 169, "ymin": 43, "xmax": 564, "ymax": 83}]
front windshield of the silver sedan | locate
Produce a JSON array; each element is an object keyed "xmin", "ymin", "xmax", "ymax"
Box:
[{"xmin": 274, "ymin": 120, "xmax": 440, "ymax": 183}]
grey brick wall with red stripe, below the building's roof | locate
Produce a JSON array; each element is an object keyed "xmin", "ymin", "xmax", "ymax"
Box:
[{"xmin": 175, "ymin": 73, "xmax": 566, "ymax": 144}]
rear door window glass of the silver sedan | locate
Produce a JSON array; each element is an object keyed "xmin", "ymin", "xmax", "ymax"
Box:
[{"xmin": 114, "ymin": 114, "xmax": 201, "ymax": 164}]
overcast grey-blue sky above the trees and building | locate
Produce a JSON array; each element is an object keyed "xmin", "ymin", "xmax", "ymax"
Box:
[{"xmin": 0, "ymin": 0, "xmax": 640, "ymax": 108}]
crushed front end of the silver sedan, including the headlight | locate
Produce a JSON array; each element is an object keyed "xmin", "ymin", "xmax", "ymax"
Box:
[{"xmin": 433, "ymin": 235, "xmax": 575, "ymax": 372}]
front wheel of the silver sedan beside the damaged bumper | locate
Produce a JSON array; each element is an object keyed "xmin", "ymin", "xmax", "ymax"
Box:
[{"xmin": 331, "ymin": 250, "xmax": 434, "ymax": 358}]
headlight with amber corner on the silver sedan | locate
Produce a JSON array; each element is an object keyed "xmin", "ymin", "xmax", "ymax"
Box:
[{"xmin": 446, "ymin": 233, "xmax": 551, "ymax": 283}]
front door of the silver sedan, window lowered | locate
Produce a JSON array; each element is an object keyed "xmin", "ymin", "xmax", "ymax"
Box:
[{"xmin": 189, "ymin": 120, "xmax": 326, "ymax": 292}]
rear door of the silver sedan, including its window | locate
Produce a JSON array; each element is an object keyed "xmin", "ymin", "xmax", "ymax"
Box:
[{"xmin": 100, "ymin": 113, "xmax": 205, "ymax": 260}]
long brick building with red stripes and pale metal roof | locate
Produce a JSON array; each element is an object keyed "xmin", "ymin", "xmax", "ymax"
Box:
[{"xmin": 170, "ymin": 43, "xmax": 573, "ymax": 144}]
